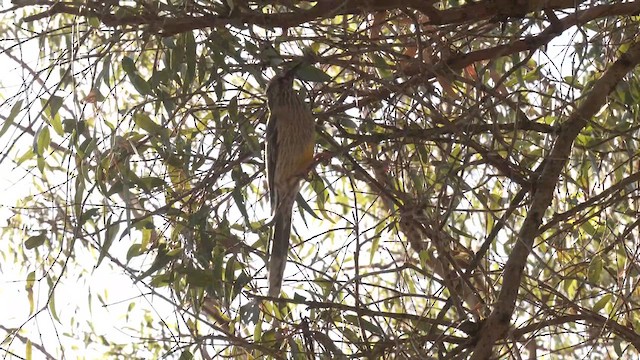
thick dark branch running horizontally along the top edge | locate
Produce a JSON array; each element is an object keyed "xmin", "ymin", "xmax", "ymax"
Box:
[{"xmin": 13, "ymin": 0, "xmax": 604, "ymax": 36}]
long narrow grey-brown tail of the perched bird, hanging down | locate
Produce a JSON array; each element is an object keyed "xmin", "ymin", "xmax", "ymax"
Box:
[{"xmin": 269, "ymin": 202, "xmax": 293, "ymax": 297}]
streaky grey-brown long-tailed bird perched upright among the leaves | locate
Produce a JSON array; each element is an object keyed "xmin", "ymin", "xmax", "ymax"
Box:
[{"xmin": 265, "ymin": 68, "xmax": 315, "ymax": 297}]
